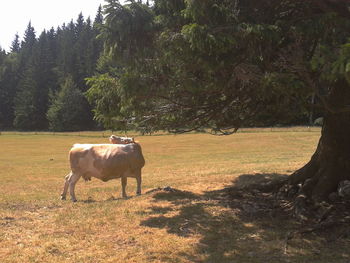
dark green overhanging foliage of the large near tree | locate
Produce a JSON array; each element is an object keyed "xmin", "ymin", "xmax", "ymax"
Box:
[{"xmin": 87, "ymin": 0, "xmax": 350, "ymax": 134}]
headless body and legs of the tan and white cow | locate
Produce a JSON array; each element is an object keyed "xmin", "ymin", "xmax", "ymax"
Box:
[{"xmin": 61, "ymin": 143, "xmax": 145, "ymax": 202}]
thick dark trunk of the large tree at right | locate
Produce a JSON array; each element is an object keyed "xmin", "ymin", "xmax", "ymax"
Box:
[{"xmin": 288, "ymin": 80, "xmax": 350, "ymax": 202}]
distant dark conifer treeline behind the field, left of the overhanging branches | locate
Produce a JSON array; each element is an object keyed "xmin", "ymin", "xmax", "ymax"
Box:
[{"xmin": 0, "ymin": 6, "xmax": 103, "ymax": 131}]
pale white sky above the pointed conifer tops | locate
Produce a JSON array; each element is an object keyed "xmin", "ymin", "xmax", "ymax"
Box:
[{"xmin": 0, "ymin": 0, "xmax": 106, "ymax": 51}]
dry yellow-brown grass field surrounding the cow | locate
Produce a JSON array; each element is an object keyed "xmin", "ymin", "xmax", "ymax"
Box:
[{"xmin": 0, "ymin": 129, "xmax": 350, "ymax": 263}]
